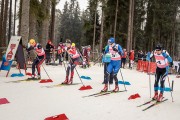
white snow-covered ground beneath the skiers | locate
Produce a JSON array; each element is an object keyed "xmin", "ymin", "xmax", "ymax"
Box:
[{"xmin": 0, "ymin": 62, "xmax": 180, "ymax": 120}]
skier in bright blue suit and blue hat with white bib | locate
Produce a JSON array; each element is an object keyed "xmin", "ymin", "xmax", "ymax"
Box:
[{"xmin": 101, "ymin": 38, "xmax": 124, "ymax": 92}]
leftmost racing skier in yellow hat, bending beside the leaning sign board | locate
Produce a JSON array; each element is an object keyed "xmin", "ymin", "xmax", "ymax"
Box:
[{"xmin": 27, "ymin": 39, "xmax": 46, "ymax": 79}]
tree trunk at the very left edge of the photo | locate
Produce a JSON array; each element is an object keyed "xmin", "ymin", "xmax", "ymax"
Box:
[{"xmin": 0, "ymin": 0, "xmax": 4, "ymax": 46}]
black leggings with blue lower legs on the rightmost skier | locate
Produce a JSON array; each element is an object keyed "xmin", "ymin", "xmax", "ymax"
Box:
[{"xmin": 154, "ymin": 67, "xmax": 167, "ymax": 93}]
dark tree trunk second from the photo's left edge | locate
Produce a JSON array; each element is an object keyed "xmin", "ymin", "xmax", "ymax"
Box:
[{"xmin": 2, "ymin": 0, "xmax": 9, "ymax": 47}]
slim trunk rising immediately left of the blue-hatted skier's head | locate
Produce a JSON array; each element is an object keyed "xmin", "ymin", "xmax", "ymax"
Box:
[{"xmin": 99, "ymin": 5, "xmax": 104, "ymax": 52}]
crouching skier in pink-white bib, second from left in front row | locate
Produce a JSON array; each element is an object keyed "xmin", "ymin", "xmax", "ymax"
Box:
[{"xmin": 62, "ymin": 40, "xmax": 80, "ymax": 84}]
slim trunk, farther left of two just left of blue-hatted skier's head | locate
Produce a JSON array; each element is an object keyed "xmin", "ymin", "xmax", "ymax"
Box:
[{"xmin": 93, "ymin": 2, "xmax": 97, "ymax": 60}]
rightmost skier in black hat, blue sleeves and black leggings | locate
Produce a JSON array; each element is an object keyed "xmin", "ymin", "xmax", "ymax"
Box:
[{"xmin": 146, "ymin": 45, "xmax": 172, "ymax": 102}]
